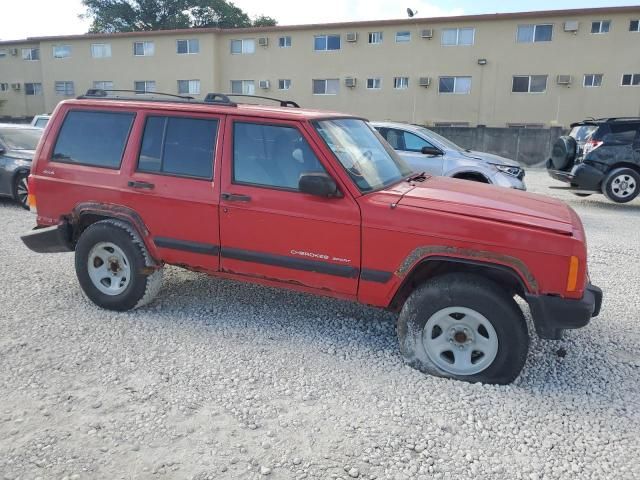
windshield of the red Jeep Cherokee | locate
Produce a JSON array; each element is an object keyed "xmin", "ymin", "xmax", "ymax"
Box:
[{"xmin": 315, "ymin": 118, "xmax": 412, "ymax": 192}]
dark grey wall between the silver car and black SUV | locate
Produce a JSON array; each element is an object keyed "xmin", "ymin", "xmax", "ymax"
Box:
[{"xmin": 429, "ymin": 127, "xmax": 566, "ymax": 166}]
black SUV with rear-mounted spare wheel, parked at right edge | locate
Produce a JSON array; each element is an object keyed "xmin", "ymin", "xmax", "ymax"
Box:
[{"xmin": 547, "ymin": 118, "xmax": 640, "ymax": 203}]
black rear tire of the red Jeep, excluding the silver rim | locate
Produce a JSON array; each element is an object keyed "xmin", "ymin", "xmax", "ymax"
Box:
[{"xmin": 75, "ymin": 220, "xmax": 162, "ymax": 311}]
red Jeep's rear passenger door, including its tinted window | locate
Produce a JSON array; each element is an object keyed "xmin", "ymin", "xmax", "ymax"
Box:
[{"xmin": 123, "ymin": 111, "xmax": 223, "ymax": 271}]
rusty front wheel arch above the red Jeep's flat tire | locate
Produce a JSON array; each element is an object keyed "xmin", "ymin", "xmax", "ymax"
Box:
[{"xmin": 389, "ymin": 255, "xmax": 537, "ymax": 311}]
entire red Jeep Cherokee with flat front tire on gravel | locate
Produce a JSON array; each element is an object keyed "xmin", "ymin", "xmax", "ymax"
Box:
[{"xmin": 22, "ymin": 91, "xmax": 602, "ymax": 384}]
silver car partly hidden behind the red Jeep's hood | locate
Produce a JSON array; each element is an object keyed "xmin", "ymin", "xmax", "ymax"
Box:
[{"xmin": 372, "ymin": 122, "xmax": 526, "ymax": 190}]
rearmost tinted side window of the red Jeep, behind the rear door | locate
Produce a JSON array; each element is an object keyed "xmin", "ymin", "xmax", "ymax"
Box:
[{"xmin": 52, "ymin": 111, "xmax": 135, "ymax": 169}]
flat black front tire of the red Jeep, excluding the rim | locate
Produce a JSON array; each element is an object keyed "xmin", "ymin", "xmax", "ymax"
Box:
[{"xmin": 398, "ymin": 273, "xmax": 529, "ymax": 385}]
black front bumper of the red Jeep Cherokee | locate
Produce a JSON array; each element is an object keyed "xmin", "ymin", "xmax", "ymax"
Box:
[{"xmin": 526, "ymin": 284, "xmax": 602, "ymax": 340}]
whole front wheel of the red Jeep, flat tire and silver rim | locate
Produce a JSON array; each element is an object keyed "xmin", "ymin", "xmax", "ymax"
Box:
[{"xmin": 398, "ymin": 274, "xmax": 529, "ymax": 385}]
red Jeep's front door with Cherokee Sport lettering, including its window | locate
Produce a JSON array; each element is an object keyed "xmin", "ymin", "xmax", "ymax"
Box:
[{"xmin": 220, "ymin": 117, "xmax": 360, "ymax": 296}]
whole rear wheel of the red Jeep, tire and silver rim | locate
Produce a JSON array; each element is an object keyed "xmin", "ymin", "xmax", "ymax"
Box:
[{"xmin": 75, "ymin": 220, "xmax": 162, "ymax": 311}]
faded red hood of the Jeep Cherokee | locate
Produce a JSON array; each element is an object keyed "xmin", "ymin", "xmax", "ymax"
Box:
[{"xmin": 399, "ymin": 177, "xmax": 574, "ymax": 235}]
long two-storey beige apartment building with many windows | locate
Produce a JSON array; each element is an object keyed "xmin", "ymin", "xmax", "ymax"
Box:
[{"xmin": 0, "ymin": 6, "xmax": 640, "ymax": 127}]
